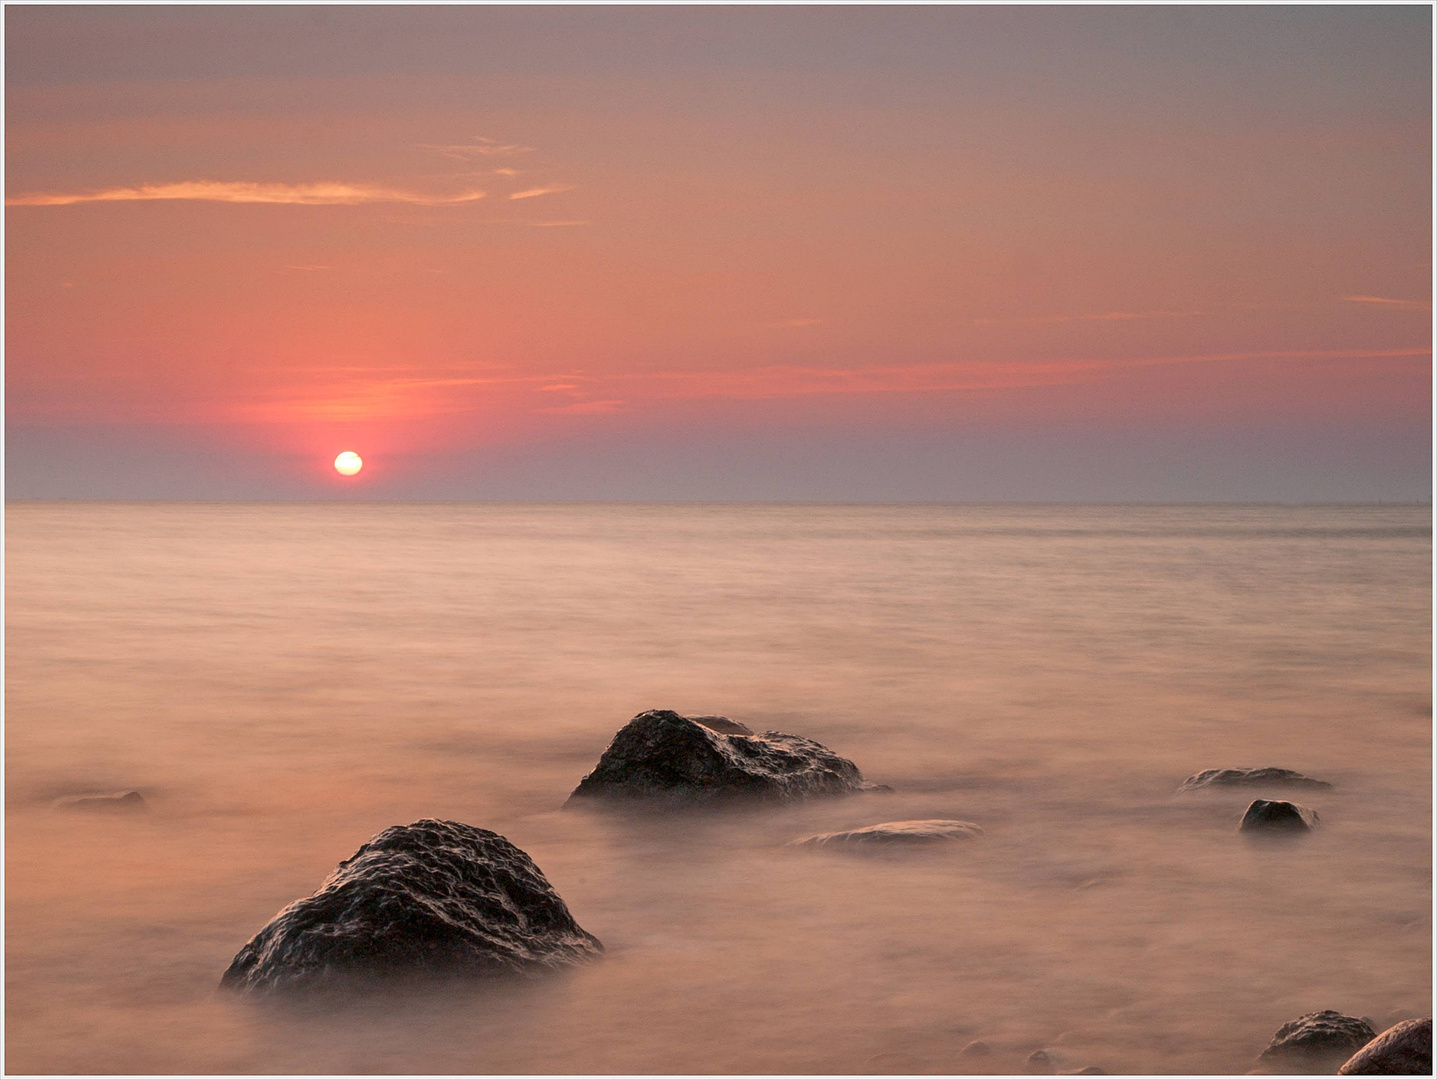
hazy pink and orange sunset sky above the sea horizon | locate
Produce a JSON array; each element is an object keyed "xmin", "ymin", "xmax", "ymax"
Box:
[{"xmin": 4, "ymin": 6, "xmax": 1433, "ymax": 503}]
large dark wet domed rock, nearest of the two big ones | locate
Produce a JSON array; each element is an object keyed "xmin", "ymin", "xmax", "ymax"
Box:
[{"xmin": 220, "ymin": 819, "xmax": 604, "ymax": 992}]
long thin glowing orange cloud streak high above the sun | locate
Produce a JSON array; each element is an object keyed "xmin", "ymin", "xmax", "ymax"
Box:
[{"xmin": 6, "ymin": 180, "xmax": 486, "ymax": 207}]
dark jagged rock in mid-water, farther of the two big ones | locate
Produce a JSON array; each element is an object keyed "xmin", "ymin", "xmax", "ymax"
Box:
[{"xmin": 569, "ymin": 709, "xmax": 864, "ymax": 803}]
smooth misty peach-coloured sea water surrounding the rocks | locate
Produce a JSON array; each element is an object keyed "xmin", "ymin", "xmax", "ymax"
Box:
[{"xmin": 4, "ymin": 503, "xmax": 1431, "ymax": 1073}]
